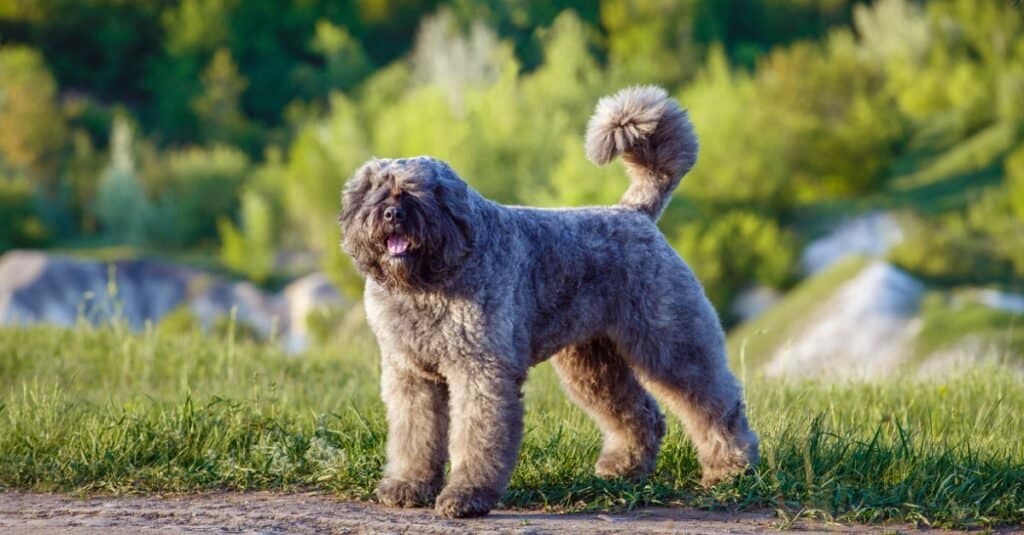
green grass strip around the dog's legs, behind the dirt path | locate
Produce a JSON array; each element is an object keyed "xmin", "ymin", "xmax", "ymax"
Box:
[{"xmin": 0, "ymin": 319, "xmax": 1024, "ymax": 527}]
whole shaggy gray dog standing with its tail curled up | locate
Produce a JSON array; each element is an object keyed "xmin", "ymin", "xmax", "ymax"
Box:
[{"xmin": 339, "ymin": 87, "xmax": 758, "ymax": 517}]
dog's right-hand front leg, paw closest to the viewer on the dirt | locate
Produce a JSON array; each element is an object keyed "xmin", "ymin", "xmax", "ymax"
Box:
[{"xmin": 435, "ymin": 359, "xmax": 525, "ymax": 518}]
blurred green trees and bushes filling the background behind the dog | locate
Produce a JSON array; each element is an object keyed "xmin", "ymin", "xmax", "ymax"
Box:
[{"xmin": 0, "ymin": 0, "xmax": 1024, "ymax": 321}]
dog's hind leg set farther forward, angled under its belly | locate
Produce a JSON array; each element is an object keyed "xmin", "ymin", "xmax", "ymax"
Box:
[{"xmin": 552, "ymin": 337, "xmax": 665, "ymax": 478}]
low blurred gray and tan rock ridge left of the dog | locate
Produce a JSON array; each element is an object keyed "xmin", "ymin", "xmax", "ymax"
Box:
[{"xmin": 0, "ymin": 251, "xmax": 347, "ymax": 352}]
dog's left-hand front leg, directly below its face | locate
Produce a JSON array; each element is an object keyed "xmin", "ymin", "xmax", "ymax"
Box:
[{"xmin": 377, "ymin": 357, "xmax": 449, "ymax": 507}]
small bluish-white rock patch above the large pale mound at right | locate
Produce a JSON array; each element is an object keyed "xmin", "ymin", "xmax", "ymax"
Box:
[{"xmin": 801, "ymin": 212, "xmax": 903, "ymax": 274}]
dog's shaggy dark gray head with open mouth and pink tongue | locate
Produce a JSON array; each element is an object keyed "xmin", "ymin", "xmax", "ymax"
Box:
[{"xmin": 338, "ymin": 157, "xmax": 473, "ymax": 289}]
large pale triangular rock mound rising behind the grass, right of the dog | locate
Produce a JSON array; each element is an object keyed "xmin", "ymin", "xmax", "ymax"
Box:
[{"xmin": 764, "ymin": 260, "xmax": 925, "ymax": 381}]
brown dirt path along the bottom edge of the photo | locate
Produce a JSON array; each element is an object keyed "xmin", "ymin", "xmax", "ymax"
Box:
[{"xmin": 0, "ymin": 492, "xmax": 999, "ymax": 535}]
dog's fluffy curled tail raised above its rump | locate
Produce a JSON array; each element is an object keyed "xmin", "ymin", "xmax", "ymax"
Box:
[{"xmin": 587, "ymin": 86, "xmax": 697, "ymax": 220}]
